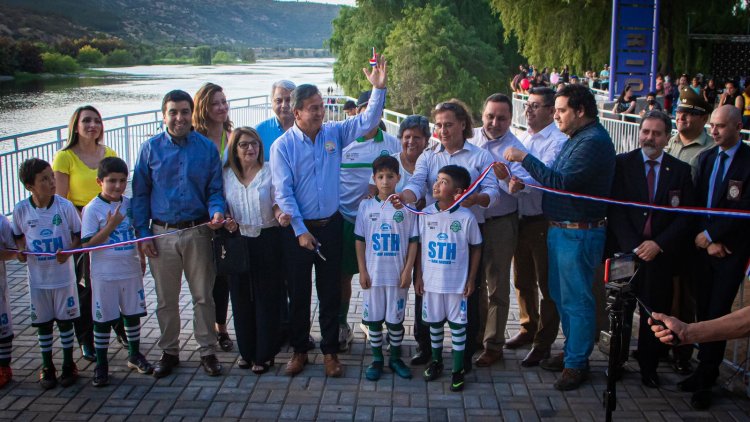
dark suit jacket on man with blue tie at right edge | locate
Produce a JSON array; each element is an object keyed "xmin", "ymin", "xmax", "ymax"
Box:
[{"xmin": 695, "ymin": 142, "xmax": 750, "ymax": 256}]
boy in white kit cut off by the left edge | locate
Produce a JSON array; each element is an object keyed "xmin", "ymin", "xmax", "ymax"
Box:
[{"xmin": 0, "ymin": 214, "xmax": 18, "ymax": 388}]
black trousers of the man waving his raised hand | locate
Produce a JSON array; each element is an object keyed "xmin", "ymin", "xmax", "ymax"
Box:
[{"xmin": 282, "ymin": 212, "xmax": 343, "ymax": 354}]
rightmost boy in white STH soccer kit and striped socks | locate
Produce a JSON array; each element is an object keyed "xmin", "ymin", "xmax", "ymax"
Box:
[{"xmin": 414, "ymin": 165, "xmax": 482, "ymax": 391}]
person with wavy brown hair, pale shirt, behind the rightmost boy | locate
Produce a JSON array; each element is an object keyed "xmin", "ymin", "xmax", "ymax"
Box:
[{"xmin": 393, "ymin": 99, "xmax": 500, "ymax": 371}]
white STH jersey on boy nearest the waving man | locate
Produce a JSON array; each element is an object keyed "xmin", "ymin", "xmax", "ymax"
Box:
[{"xmin": 354, "ymin": 196, "xmax": 419, "ymax": 286}]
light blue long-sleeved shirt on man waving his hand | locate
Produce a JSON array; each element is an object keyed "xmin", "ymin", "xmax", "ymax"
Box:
[{"xmin": 270, "ymin": 89, "xmax": 386, "ymax": 236}]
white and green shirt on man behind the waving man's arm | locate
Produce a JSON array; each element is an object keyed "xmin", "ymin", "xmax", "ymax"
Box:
[{"xmin": 339, "ymin": 129, "xmax": 401, "ymax": 223}]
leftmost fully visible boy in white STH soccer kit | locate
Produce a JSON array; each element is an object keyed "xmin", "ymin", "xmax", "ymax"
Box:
[{"xmin": 13, "ymin": 158, "xmax": 81, "ymax": 390}]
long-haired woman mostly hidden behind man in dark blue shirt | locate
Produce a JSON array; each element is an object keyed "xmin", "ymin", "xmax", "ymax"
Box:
[{"xmin": 193, "ymin": 82, "xmax": 234, "ymax": 352}]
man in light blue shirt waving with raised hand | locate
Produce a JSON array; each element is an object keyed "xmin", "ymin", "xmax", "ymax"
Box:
[{"xmin": 270, "ymin": 57, "xmax": 386, "ymax": 377}]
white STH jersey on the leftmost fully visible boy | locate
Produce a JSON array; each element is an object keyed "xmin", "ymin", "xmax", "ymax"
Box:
[{"xmin": 13, "ymin": 195, "xmax": 81, "ymax": 289}]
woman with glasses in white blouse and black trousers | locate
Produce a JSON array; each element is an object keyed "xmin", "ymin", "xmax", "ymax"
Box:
[{"xmin": 223, "ymin": 127, "xmax": 291, "ymax": 374}]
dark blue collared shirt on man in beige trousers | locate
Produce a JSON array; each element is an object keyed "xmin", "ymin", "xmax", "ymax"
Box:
[{"xmin": 133, "ymin": 130, "xmax": 224, "ymax": 236}]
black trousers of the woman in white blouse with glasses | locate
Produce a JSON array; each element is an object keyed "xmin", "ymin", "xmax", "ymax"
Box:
[{"xmin": 228, "ymin": 227, "xmax": 284, "ymax": 364}]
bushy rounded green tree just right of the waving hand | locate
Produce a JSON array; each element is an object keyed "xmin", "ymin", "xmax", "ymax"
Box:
[{"xmin": 384, "ymin": 5, "xmax": 505, "ymax": 115}]
